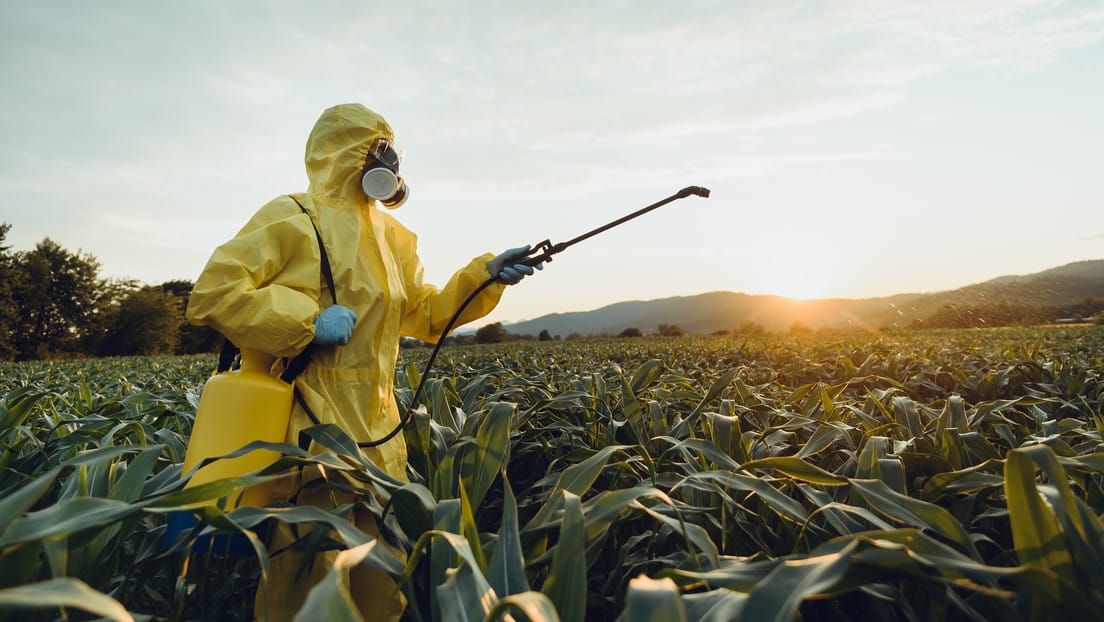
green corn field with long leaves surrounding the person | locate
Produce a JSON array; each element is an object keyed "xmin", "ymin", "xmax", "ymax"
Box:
[{"xmin": 0, "ymin": 327, "xmax": 1104, "ymax": 621}]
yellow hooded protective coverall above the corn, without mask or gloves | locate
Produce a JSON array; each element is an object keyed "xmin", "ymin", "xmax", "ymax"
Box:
[{"xmin": 187, "ymin": 104, "xmax": 506, "ymax": 481}]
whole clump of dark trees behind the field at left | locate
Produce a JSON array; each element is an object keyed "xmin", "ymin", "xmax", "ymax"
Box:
[{"xmin": 0, "ymin": 223, "xmax": 222, "ymax": 360}]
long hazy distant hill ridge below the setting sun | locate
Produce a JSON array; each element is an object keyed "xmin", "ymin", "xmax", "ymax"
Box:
[{"xmin": 506, "ymin": 260, "xmax": 1104, "ymax": 337}]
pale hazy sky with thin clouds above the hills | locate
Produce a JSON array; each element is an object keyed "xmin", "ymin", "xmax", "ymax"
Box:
[{"xmin": 0, "ymin": 0, "xmax": 1104, "ymax": 325}]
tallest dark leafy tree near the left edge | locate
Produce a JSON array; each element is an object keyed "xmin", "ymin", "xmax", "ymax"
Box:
[{"xmin": 11, "ymin": 238, "xmax": 107, "ymax": 359}]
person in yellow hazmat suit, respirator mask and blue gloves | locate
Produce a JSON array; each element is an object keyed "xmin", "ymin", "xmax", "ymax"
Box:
[{"xmin": 187, "ymin": 104, "xmax": 540, "ymax": 620}]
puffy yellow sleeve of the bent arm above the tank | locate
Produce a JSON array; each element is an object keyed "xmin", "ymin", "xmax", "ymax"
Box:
[{"xmin": 185, "ymin": 199, "xmax": 321, "ymax": 357}]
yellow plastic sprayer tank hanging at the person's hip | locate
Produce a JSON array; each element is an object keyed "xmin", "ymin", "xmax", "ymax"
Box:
[{"xmin": 182, "ymin": 350, "xmax": 293, "ymax": 507}]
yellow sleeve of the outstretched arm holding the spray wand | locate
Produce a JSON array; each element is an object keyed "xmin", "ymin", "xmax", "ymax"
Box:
[{"xmin": 392, "ymin": 221, "xmax": 506, "ymax": 341}]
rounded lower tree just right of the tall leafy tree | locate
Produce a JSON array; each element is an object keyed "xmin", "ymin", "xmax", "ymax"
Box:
[{"xmin": 102, "ymin": 285, "xmax": 181, "ymax": 355}]
